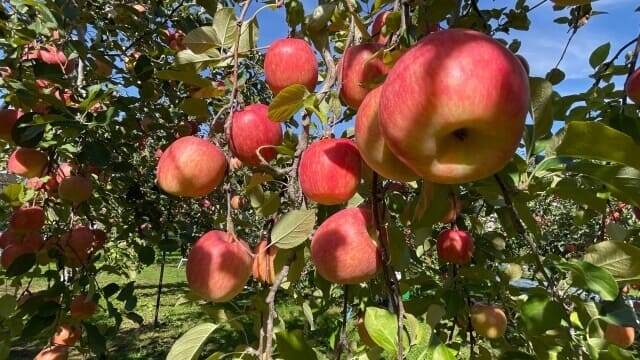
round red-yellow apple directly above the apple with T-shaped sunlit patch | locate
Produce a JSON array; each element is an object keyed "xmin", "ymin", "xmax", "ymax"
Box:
[{"xmin": 156, "ymin": 136, "xmax": 227, "ymax": 197}]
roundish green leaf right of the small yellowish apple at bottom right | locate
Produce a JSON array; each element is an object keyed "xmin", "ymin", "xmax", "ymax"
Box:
[{"xmin": 522, "ymin": 295, "xmax": 564, "ymax": 334}]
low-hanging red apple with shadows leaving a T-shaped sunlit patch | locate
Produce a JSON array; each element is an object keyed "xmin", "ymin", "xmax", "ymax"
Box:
[{"xmin": 187, "ymin": 230, "xmax": 253, "ymax": 302}]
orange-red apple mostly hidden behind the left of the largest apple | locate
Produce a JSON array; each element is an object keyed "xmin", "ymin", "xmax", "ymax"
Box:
[{"xmin": 355, "ymin": 87, "xmax": 419, "ymax": 182}]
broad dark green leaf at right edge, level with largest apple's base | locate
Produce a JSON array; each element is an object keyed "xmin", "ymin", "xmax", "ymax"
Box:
[{"xmin": 556, "ymin": 121, "xmax": 640, "ymax": 169}]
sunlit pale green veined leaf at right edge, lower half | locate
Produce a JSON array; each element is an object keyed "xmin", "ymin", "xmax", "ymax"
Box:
[{"xmin": 584, "ymin": 241, "xmax": 640, "ymax": 281}]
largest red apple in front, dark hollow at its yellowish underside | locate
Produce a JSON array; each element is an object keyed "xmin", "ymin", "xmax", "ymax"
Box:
[{"xmin": 379, "ymin": 29, "xmax": 529, "ymax": 184}]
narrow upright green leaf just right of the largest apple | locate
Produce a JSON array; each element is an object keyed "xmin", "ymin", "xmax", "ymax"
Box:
[{"xmin": 529, "ymin": 78, "xmax": 553, "ymax": 140}]
